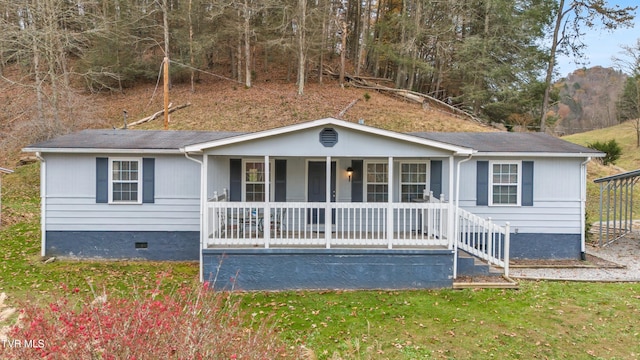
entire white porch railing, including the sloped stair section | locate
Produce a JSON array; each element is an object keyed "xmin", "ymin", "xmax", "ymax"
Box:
[{"xmin": 204, "ymin": 193, "xmax": 510, "ymax": 276}]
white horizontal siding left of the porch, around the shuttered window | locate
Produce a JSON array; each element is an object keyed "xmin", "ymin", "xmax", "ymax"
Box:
[{"xmin": 45, "ymin": 154, "xmax": 200, "ymax": 231}]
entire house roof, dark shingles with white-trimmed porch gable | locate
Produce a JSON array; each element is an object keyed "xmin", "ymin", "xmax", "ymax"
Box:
[{"xmin": 23, "ymin": 118, "xmax": 604, "ymax": 157}]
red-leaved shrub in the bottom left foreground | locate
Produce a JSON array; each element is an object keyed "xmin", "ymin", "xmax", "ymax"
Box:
[{"xmin": 0, "ymin": 283, "xmax": 292, "ymax": 359}]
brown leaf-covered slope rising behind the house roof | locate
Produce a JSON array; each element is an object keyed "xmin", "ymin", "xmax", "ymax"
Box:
[{"xmin": 0, "ymin": 63, "xmax": 495, "ymax": 168}]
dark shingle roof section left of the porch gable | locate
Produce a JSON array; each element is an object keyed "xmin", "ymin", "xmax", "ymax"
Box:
[{"xmin": 27, "ymin": 130, "xmax": 244, "ymax": 150}]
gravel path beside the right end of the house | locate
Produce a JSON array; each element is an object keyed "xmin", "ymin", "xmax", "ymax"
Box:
[{"xmin": 510, "ymin": 230, "xmax": 640, "ymax": 282}]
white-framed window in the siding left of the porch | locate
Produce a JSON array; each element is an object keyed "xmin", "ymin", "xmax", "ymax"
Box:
[{"xmin": 109, "ymin": 159, "xmax": 142, "ymax": 204}]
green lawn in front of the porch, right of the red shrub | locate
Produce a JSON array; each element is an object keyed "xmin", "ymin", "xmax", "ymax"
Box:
[{"xmin": 244, "ymin": 282, "xmax": 640, "ymax": 359}]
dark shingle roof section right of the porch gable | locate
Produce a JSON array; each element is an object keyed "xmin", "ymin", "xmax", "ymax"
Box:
[{"xmin": 411, "ymin": 132, "xmax": 600, "ymax": 155}]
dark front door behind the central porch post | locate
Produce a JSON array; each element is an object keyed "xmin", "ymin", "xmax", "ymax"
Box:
[{"xmin": 307, "ymin": 161, "xmax": 336, "ymax": 224}]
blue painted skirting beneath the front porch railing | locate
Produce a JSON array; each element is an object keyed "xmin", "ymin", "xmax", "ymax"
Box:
[{"xmin": 202, "ymin": 248, "xmax": 453, "ymax": 290}]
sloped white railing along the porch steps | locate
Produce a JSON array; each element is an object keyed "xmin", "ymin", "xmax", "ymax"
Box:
[{"xmin": 454, "ymin": 209, "xmax": 510, "ymax": 276}]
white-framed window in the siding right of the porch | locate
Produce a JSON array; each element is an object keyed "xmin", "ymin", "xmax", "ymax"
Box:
[{"xmin": 489, "ymin": 162, "xmax": 520, "ymax": 205}]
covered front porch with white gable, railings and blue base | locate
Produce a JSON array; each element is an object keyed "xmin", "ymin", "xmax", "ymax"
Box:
[{"xmin": 184, "ymin": 119, "xmax": 509, "ymax": 290}]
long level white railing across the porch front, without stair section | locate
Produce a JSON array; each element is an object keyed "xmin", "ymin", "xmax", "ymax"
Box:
[{"xmin": 205, "ymin": 201, "xmax": 451, "ymax": 248}]
